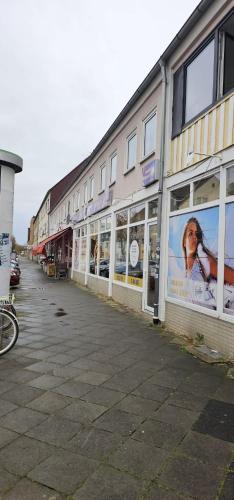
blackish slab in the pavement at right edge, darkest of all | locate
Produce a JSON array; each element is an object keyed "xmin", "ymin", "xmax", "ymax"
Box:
[{"xmin": 193, "ymin": 399, "xmax": 234, "ymax": 443}]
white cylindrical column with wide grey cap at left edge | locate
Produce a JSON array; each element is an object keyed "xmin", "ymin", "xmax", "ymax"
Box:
[{"xmin": 0, "ymin": 150, "xmax": 23, "ymax": 297}]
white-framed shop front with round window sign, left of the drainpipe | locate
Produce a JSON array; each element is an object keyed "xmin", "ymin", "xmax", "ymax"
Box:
[{"xmin": 72, "ymin": 198, "xmax": 158, "ymax": 313}]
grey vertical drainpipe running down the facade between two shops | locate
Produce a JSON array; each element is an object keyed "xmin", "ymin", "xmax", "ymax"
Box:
[{"xmin": 153, "ymin": 59, "xmax": 167, "ymax": 324}]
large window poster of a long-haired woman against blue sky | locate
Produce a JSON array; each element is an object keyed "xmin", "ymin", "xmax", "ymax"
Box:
[{"xmin": 168, "ymin": 207, "xmax": 219, "ymax": 309}]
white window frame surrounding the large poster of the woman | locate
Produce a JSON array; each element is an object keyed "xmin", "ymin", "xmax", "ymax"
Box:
[{"xmin": 165, "ymin": 161, "xmax": 234, "ymax": 323}]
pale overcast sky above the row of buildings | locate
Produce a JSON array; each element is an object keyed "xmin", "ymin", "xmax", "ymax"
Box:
[{"xmin": 0, "ymin": 0, "xmax": 198, "ymax": 244}]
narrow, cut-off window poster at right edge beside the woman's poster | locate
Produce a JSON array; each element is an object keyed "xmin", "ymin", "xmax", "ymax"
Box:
[{"xmin": 223, "ymin": 203, "xmax": 234, "ymax": 316}]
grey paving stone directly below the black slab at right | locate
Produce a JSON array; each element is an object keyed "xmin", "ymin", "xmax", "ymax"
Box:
[{"xmin": 177, "ymin": 432, "xmax": 234, "ymax": 468}]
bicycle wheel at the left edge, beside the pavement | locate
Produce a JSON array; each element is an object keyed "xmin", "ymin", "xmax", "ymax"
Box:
[{"xmin": 0, "ymin": 309, "xmax": 19, "ymax": 356}]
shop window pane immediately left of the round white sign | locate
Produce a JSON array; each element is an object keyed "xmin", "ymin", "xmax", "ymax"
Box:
[{"xmin": 114, "ymin": 228, "xmax": 127, "ymax": 282}]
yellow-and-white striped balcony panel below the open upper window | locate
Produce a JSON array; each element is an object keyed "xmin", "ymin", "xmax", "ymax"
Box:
[{"xmin": 168, "ymin": 92, "xmax": 234, "ymax": 175}]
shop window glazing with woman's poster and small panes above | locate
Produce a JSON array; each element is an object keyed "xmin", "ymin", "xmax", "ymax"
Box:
[{"xmin": 167, "ymin": 167, "xmax": 234, "ymax": 317}]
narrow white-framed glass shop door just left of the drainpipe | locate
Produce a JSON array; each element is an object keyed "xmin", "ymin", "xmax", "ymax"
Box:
[{"xmin": 145, "ymin": 222, "xmax": 157, "ymax": 311}]
